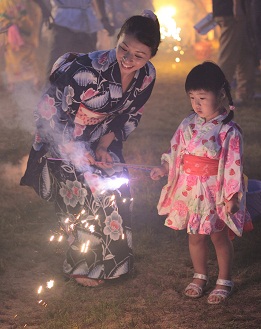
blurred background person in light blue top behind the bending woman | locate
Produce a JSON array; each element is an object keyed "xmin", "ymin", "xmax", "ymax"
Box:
[{"xmin": 47, "ymin": 0, "xmax": 114, "ymax": 76}]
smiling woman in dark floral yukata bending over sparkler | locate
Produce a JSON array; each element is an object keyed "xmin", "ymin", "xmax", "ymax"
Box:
[{"xmin": 21, "ymin": 11, "xmax": 160, "ymax": 286}]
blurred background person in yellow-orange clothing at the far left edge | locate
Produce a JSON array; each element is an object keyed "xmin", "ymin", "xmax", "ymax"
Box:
[{"xmin": 0, "ymin": 0, "xmax": 42, "ymax": 91}]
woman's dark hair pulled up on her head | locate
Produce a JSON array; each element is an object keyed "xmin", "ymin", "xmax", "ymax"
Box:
[{"xmin": 117, "ymin": 15, "xmax": 161, "ymax": 57}]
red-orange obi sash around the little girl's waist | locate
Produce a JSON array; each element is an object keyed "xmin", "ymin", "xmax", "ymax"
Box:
[{"xmin": 183, "ymin": 154, "xmax": 219, "ymax": 176}]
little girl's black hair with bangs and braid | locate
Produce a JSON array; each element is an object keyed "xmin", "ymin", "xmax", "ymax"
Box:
[{"xmin": 185, "ymin": 61, "xmax": 234, "ymax": 123}]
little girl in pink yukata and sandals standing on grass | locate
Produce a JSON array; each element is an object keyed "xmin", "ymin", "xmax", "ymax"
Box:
[{"xmin": 151, "ymin": 62, "xmax": 251, "ymax": 304}]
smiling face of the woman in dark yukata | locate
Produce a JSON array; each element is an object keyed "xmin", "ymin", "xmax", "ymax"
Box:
[{"xmin": 116, "ymin": 34, "xmax": 151, "ymax": 75}]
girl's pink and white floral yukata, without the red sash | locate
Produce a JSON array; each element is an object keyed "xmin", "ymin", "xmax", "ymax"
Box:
[{"xmin": 158, "ymin": 112, "xmax": 251, "ymax": 236}]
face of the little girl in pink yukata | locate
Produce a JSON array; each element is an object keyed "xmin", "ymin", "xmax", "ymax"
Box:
[{"xmin": 188, "ymin": 89, "xmax": 224, "ymax": 122}]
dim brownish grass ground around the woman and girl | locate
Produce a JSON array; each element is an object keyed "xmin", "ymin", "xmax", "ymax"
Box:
[{"xmin": 0, "ymin": 47, "xmax": 261, "ymax": 329}]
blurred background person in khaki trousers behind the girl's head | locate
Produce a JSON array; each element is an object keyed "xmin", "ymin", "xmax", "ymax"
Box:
[{"xmin": 212, "ymin": 0, "xmax": 256, "ymax": 105}]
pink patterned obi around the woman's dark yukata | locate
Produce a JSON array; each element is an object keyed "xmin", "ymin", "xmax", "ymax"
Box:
[{"xmin": 74, "ymin": 104, "xmax": 108, "ymax": 126}]
